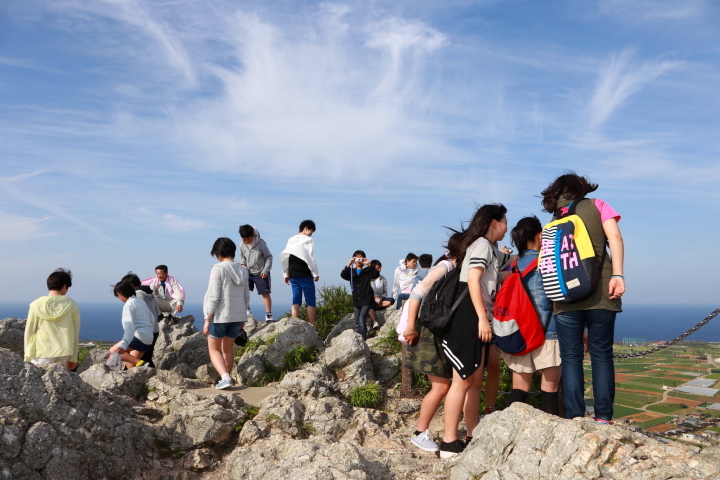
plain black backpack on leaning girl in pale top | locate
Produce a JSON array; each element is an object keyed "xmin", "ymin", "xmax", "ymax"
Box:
[{"xmin": 419, "ymin": 260, "xmax": 468, "ymax": 337}]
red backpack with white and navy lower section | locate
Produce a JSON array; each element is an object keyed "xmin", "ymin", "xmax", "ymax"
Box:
[{"xmin": 492, "ymin": 258, "xmax": 545, "ymax": 355}]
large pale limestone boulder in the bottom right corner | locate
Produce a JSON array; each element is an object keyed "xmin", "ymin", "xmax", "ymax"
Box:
[{"xmin": 448, "ymin": 403, "xmax": 720, "ymax": 480}]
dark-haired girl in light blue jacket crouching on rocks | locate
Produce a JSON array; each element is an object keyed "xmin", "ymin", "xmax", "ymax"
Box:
[{"xmin": 110, "ymin": 282, "xmax": 155, "ymax": 368}]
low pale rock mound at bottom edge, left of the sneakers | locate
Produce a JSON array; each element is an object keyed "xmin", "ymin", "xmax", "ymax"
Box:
[{"xmin": 220, "ymin": 435, "xmax": 396, "ymax": 480}]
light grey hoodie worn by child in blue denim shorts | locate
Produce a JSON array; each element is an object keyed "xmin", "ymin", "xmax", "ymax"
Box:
[{"xmin": 203, "ymin": 262, "xmax": 250, "ymax": 323}]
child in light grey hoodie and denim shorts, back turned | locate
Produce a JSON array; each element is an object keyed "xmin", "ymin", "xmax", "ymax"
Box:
[{"xmin": 203, "ymin": 237, "xmax": 250, "ymax": 390}]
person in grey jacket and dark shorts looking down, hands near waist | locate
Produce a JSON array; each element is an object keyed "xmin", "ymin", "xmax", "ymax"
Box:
[{"xmin": 240, "ymin": 225, "xmax": 273, "ymax": 322}]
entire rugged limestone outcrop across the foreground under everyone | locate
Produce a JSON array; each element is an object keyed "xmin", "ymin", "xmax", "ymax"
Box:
[{"xmin": 0, "ymin": 315, "xmax": 720, "ymax": 480}]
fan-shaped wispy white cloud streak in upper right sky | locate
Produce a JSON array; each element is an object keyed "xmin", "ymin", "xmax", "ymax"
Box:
[{"xmin": 587, "ymin": 48, "xmax": 682, "ymax": 129}]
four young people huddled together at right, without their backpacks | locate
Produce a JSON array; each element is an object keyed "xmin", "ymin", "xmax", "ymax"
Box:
[{"xmin": 400, "ymin": 173, "xmax": 625, "ymax": 458}]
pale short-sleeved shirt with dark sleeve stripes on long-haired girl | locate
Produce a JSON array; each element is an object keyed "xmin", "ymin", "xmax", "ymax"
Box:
[{"xmin": 460, "ymin": 237, "xmax": 510, "ymax": 312}]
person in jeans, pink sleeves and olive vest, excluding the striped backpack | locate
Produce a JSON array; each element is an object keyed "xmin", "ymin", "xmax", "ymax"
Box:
[{"xmin": 539, "ymin": 172, "xmax": 625, "ymax": 424}]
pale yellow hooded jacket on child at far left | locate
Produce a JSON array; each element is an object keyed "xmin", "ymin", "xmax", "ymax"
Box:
[{"xmin": 25, "ymin": 295, "xmax": 80, "ymax": 362}]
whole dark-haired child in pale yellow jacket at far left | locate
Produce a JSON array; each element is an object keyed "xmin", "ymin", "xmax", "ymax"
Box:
[{"xmin": 25, "ymin": 268, "xmax": 80, "ymax": 370}]
